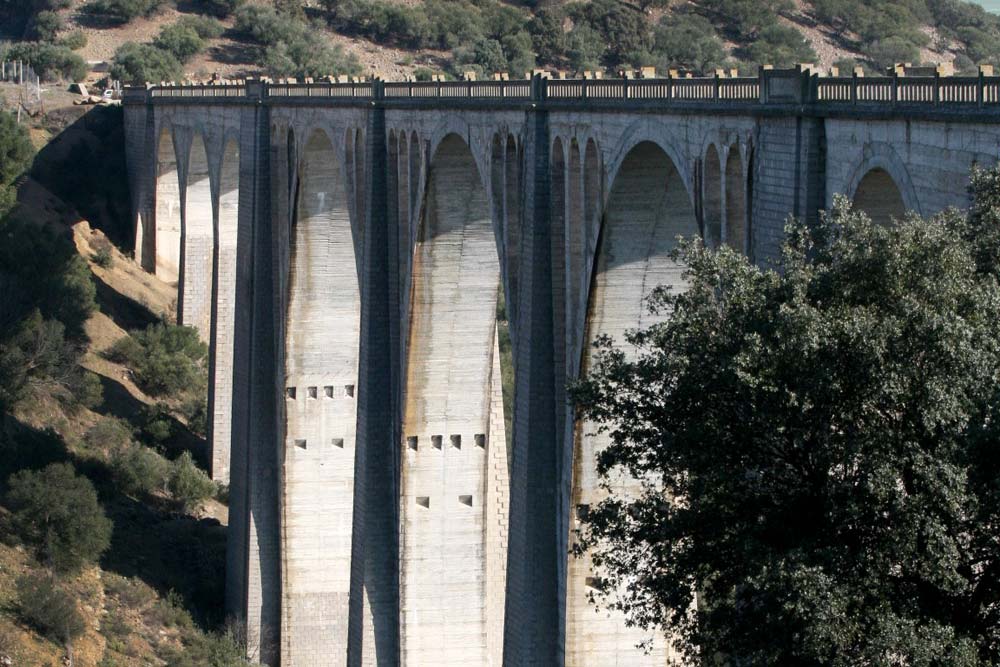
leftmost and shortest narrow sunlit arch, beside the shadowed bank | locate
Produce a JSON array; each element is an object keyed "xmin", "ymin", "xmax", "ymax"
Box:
[{"xmin": 154, "ymin": 128, "xmax": 181, "ymax": 283}]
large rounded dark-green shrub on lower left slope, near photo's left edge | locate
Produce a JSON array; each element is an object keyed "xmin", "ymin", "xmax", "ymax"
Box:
[{"xmin": 6, "ymin": 463, "xmax": 111, "ymax": 572}]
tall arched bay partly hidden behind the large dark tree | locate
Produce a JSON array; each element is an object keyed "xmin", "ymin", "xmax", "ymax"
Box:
[{"xmin": 566, "ymin": 142, "xmax": 698, "ymax": 667}]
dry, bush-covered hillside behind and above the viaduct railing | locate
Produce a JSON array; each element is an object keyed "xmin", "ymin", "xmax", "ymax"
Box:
[{"xmin": 0, "ymin": 0, "xmax": 1000, "ymax": 88}]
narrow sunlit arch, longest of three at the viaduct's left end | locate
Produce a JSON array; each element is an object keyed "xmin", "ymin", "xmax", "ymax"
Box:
[{"xmin": 209, "ymin": 139, "xmax": 240, "ymax": 483}]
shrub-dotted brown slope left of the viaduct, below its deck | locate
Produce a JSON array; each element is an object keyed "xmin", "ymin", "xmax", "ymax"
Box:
[{"xmin": 0, "ymin": 100, "xmax": 256, "ymax": 667}]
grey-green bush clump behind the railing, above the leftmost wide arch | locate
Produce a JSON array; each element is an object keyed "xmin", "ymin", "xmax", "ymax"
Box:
[{"xmin": 236, "ymin": 5, "xmax": 361, "ymax": 77}]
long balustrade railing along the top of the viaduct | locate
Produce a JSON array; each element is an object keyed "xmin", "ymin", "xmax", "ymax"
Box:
[{"xmin": 131, "ymin": 66, "xmax": 1000, "ymax": 108}]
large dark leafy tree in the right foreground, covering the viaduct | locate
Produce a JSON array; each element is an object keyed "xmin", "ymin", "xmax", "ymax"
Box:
[{"xmin": 572, "ymin": 171, "xmax": 1000, "ymax": 667}]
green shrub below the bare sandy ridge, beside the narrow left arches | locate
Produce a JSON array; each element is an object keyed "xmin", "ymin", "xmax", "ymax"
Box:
[{"xmin": 109, "ymin": 323, "xmax": 208, "ymax": 396}]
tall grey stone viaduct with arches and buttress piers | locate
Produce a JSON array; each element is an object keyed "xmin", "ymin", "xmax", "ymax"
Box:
[{"xmin": 124, "ymin": 68, "xmax": 1000, "ymax": 667}]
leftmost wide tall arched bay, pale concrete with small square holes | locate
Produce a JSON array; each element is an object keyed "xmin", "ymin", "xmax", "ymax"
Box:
[{"xmin": 281, "ymin": 131, "xmax": 361, "ymax": 665}]
